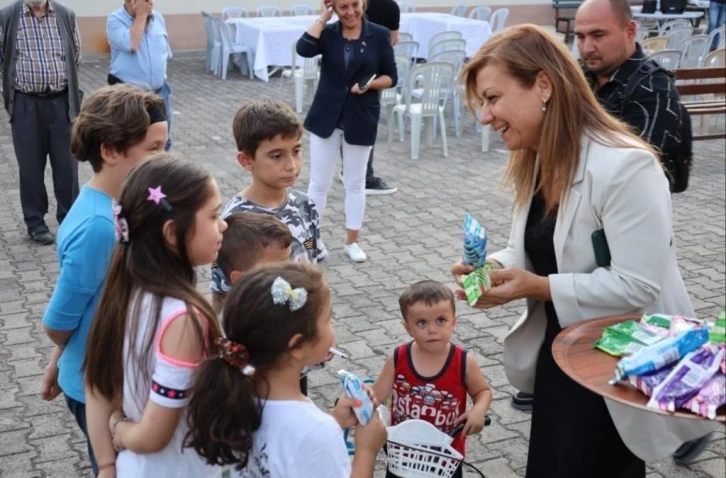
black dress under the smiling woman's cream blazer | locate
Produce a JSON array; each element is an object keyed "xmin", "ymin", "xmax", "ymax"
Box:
[{"xmin": 524, "ymin": 193, "xmax": 657, "ymax": 478}]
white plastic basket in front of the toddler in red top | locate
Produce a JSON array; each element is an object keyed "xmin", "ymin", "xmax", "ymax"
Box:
[{"xmin": 387, "ymin": 420, "xmax": 464, "ymax": 478}]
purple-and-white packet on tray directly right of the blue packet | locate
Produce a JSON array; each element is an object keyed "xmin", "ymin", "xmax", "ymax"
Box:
[{"xmin": 647, "ymin": 347, "xmax": 724, "ymax": 412}]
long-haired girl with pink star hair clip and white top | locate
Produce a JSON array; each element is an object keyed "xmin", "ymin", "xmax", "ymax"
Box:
[{"xmin": 84, "ymin": 154, "xmax": 227, "ymax": 478}]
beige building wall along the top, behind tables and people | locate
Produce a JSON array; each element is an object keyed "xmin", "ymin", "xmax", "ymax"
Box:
[{"xmin": 59, "ymin": 0, "xmax": 554, "ymax": 53}]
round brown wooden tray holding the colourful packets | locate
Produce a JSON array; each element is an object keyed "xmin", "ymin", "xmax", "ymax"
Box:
[{"xmin": 552, "ymin": 316, "xmax": 726, "ymax": 423}]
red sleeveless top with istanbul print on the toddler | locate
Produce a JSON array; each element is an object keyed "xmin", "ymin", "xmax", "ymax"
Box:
[{"xmin": 391, "ymin": 342, "xmax": 466, "ymax": 455}]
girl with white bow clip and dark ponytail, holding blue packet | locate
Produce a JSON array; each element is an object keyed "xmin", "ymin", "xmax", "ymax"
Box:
[{"xmin": 185, "ymin": 262, "xmax": 386, "ymax": 478}]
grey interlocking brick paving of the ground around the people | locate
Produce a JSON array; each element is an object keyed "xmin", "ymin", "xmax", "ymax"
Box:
[{"xmin": 0, "ymin": 57, "xmax": 726, "ymax": 478}]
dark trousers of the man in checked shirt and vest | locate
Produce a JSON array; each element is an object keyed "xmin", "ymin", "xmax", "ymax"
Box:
[{"xmin": 10, "ymin": 91, "xmax": 78, "ymax": 233}]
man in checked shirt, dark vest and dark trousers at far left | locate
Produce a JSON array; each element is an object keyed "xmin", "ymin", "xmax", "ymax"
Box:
[{"xmin": 0, "ymin": 0, "xmax": 81, "ymax": 244}]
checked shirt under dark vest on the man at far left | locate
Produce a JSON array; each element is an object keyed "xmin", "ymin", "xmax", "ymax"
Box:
[{"xmin": 0, "ymin": 0, "xmax": 81, "ymax": 93}]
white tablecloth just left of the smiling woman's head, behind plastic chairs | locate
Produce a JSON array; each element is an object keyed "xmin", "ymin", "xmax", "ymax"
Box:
[{"xmin": 399, "ymin": 12, "xmax": 492, "ymax": 58}]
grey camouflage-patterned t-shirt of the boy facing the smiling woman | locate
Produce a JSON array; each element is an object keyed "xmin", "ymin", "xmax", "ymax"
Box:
[{"xmin": 209, "ymin": 188, "xmax": 328, "ymax": 292}]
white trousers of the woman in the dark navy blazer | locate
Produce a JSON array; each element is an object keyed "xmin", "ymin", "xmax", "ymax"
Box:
[{"xmin": 308, "ymin": 128, "xmax": 372, "ymax": 231}]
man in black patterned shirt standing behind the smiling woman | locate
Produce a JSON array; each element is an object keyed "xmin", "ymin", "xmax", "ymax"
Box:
[{"xmin": 575, "ymin": 0, "xmax": 692, "ymax": 192}]
